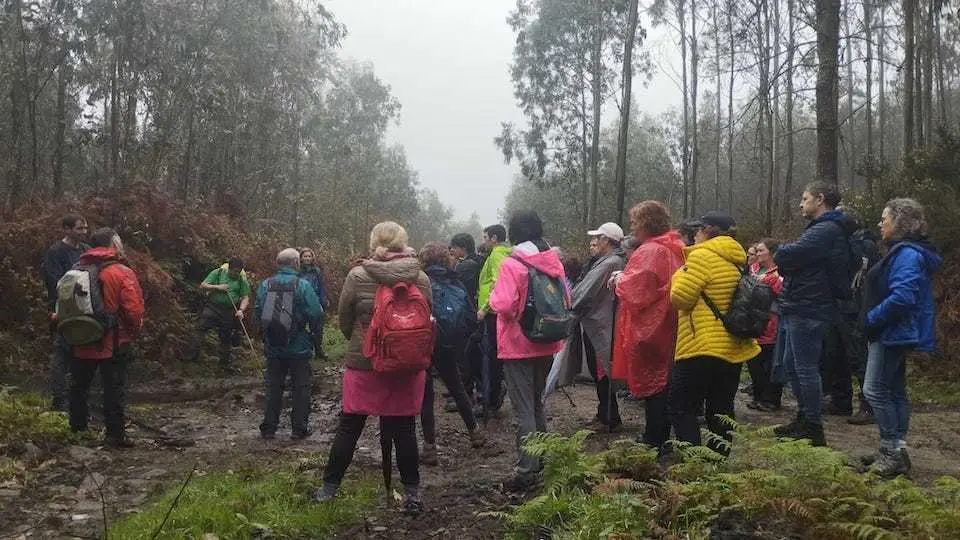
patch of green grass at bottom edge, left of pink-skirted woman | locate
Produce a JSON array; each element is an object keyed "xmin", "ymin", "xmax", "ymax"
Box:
[{"xmin": 109, "ymin": 467, "xmax": 377, "ymax": 540}]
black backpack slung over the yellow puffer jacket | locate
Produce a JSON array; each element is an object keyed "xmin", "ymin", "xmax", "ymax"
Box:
[{"xmin": 700, "ymin": 263, "xmax": 775, "ymax": 339}]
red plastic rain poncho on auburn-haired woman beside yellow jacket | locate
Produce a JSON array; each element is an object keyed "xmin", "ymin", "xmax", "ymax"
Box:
[{"xmin": 613, "ymin": 231, "xmax": 683, "ymax": 398}]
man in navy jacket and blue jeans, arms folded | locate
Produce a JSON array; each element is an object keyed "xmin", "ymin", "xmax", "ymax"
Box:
[{"xmin": 773, "ymin": 181, "xmax": 851, "ymax": 446}]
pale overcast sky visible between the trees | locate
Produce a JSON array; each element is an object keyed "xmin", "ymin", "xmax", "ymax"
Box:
[{"xmin": 326, "ymin": 0, "xmax": 680, "ymax": 224}]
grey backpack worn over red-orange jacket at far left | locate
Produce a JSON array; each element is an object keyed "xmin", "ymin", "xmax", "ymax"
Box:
[{"xmin": 56, "ymin": 261, "xmax": 117, "ymax": 346}]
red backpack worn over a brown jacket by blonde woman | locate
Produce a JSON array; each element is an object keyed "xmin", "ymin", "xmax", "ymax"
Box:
[{"xmin": 363, "ymin": 283, "xmax": 434, "ymax": 373}]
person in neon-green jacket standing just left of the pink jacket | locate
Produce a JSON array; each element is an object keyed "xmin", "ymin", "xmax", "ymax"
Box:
[{"xmin": 476, "ymin": 224, "xmax": 513, "ymax": 416}]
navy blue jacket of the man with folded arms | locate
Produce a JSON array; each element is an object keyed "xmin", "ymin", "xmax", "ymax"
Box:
[{"xmin": 773, "ymin": 210, "xmax": 856, "ymax": 321}]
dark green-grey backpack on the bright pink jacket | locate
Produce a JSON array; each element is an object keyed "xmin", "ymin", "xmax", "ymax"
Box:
[{"xmin": 512, "ymin": 255, "xmax": 574, "ymax": 343}]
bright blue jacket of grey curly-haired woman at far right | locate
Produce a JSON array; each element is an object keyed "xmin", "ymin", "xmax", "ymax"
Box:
[{"xmin": 865, "ymin": 241, "xmax": 943, "ymax": 352}]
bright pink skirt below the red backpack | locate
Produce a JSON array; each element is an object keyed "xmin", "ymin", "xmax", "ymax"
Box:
[{"xmin": 343, "ymin": 368, "xmax": 427, "ymax": 416}]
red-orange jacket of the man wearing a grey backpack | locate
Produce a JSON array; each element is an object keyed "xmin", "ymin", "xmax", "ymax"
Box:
[{"xmin": 73, "ymin": 248, "xmax": 144, "ymax": 360}]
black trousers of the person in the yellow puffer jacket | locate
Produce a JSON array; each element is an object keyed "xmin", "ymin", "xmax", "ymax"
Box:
[{"xmin": 669, "ymin": 356, "xmax": 740, "ymax": 455}]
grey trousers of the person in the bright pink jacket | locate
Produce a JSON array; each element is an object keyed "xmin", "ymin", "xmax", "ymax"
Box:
[{"xmin": 503, "ymin": 356, "xmax": 553, "ymax": 474}]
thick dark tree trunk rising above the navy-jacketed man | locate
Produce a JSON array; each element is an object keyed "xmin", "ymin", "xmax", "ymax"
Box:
[{"xmin": 816, "ymin": 0, "xmax": 840, "ymax": 184}]
